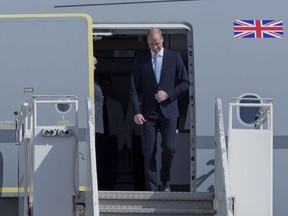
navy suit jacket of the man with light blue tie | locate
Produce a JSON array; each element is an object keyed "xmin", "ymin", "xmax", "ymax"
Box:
[{"xmin": 130, "ymin": 49, "xmax": 190, "ymax": 119}]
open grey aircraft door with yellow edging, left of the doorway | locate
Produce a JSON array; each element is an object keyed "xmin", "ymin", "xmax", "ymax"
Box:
[{"xmin": 0, "ymin": 15, "xmax": 93, "ymax": 199}]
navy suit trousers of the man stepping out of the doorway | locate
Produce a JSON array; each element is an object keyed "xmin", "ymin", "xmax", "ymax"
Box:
[{"xmin": 142, "ymin": 106, "xmax": 177, "ymax": 191}]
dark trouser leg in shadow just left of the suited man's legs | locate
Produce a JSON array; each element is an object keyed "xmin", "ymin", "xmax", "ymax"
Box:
[{"xmin": 132, "ymin": 135, "xmax": 145, "ymax": 191}]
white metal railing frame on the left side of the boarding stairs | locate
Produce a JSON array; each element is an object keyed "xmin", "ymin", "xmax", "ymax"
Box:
[{"xmin": 16, "ymin": 95, "xmax": 99, "ymax": 216}]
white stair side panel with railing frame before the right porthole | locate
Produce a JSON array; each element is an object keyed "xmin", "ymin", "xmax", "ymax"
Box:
[{"xmin": 228, "ymin": 98, "xmax": 273, "ymax": 215}]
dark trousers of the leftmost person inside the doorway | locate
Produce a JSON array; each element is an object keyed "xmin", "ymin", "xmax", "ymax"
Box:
[{"xmin": 96, "ymin": 135, "xmax": 118, "ymax": 190}]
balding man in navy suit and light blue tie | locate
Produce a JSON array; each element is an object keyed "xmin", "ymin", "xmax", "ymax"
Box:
[{"xmin": 130, "ymin": 28, "xmax": 190, "ymax": 191}]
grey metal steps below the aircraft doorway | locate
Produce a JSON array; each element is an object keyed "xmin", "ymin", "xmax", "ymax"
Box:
[{"xmin": 98, "ymin": 191, "xmax": 216, "ymax": 216}]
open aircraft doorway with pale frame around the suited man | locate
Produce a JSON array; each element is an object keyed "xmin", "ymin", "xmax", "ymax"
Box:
[{"xmin": 93, "ymin": 24, "xmax": 196, "ymax": 191}]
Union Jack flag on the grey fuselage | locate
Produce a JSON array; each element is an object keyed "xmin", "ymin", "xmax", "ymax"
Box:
[{"xmin": 234, "ymin": 20, "xmax": 284, "ymax": 38}]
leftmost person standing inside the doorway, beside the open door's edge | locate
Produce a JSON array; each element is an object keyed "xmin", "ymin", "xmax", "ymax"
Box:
[{"xmin": 97, "ymin": 76, "xmax": 124, "ymax": 190}]
